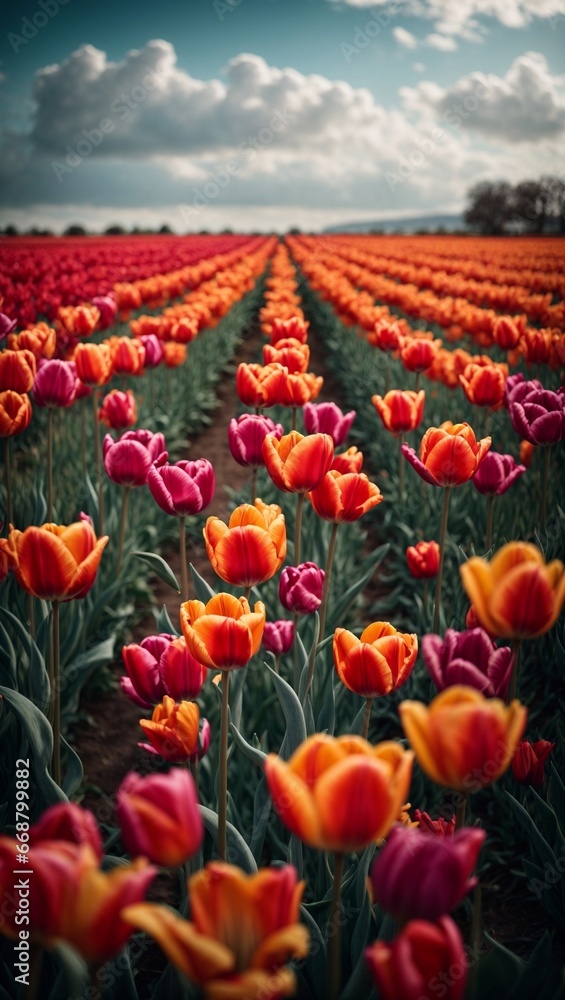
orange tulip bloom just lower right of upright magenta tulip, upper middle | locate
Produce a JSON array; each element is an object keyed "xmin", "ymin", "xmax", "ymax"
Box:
[{"xmin": 263, "ymin": 431, "xmax": 334, "ymax": 493}]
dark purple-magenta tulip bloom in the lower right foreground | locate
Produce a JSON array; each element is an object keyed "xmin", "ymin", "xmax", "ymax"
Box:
[{"xmin": 370, "ymin": 826, "xmax": 486, "ymax": 923}]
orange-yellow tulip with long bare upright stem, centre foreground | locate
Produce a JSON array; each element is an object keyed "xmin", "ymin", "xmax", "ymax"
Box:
[{"xmin": 180, "ymin": 594, "xmax": 265, "ymax": 859}]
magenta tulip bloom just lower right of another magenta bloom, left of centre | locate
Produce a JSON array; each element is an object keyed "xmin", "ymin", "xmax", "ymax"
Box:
[{"xmin": 147, "ymin": 452, "xmax": 216, "ymax": 517}]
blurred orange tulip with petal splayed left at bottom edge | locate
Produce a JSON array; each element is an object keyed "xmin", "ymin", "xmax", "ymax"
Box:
[{"xmin": 123, "ymin": 862, "xmax": 309, "ymax": 1000}]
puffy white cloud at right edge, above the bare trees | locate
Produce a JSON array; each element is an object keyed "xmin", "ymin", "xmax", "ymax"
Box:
[{"xmin": 401, "ymin": 52, "xmax": 565, "ymax": 141}]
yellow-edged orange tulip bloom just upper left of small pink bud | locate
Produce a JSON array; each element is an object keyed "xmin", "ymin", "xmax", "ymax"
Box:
[{"xmin": 204, "ymin": 500, "xmax": 286, "ymax": 587}]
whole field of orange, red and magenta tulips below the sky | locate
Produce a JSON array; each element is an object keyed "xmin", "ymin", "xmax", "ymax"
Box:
[{"xmin": 0, "ymin": 235, "xmax": 565, "ymax": 1000}]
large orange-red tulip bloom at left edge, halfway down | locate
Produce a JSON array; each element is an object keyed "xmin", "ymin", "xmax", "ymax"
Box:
[{"xmin": 8, "ymin": 521, "xmax": 108, "ymax": 601}]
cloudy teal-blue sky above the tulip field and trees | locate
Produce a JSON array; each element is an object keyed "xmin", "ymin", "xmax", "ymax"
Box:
[{"xmin": 0, "ymin": 0, "xmax": 565, "ymax": 232}]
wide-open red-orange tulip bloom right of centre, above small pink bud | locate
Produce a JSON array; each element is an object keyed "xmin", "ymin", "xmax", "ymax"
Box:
[{"xmin": 308, "ymin": 469, "xmax": 384, "ymax": 524}]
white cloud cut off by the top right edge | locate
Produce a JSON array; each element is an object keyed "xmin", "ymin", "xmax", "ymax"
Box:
[{"xmin": 328, "ymin": 0, "xmax": 565, "ymax": 41}]
